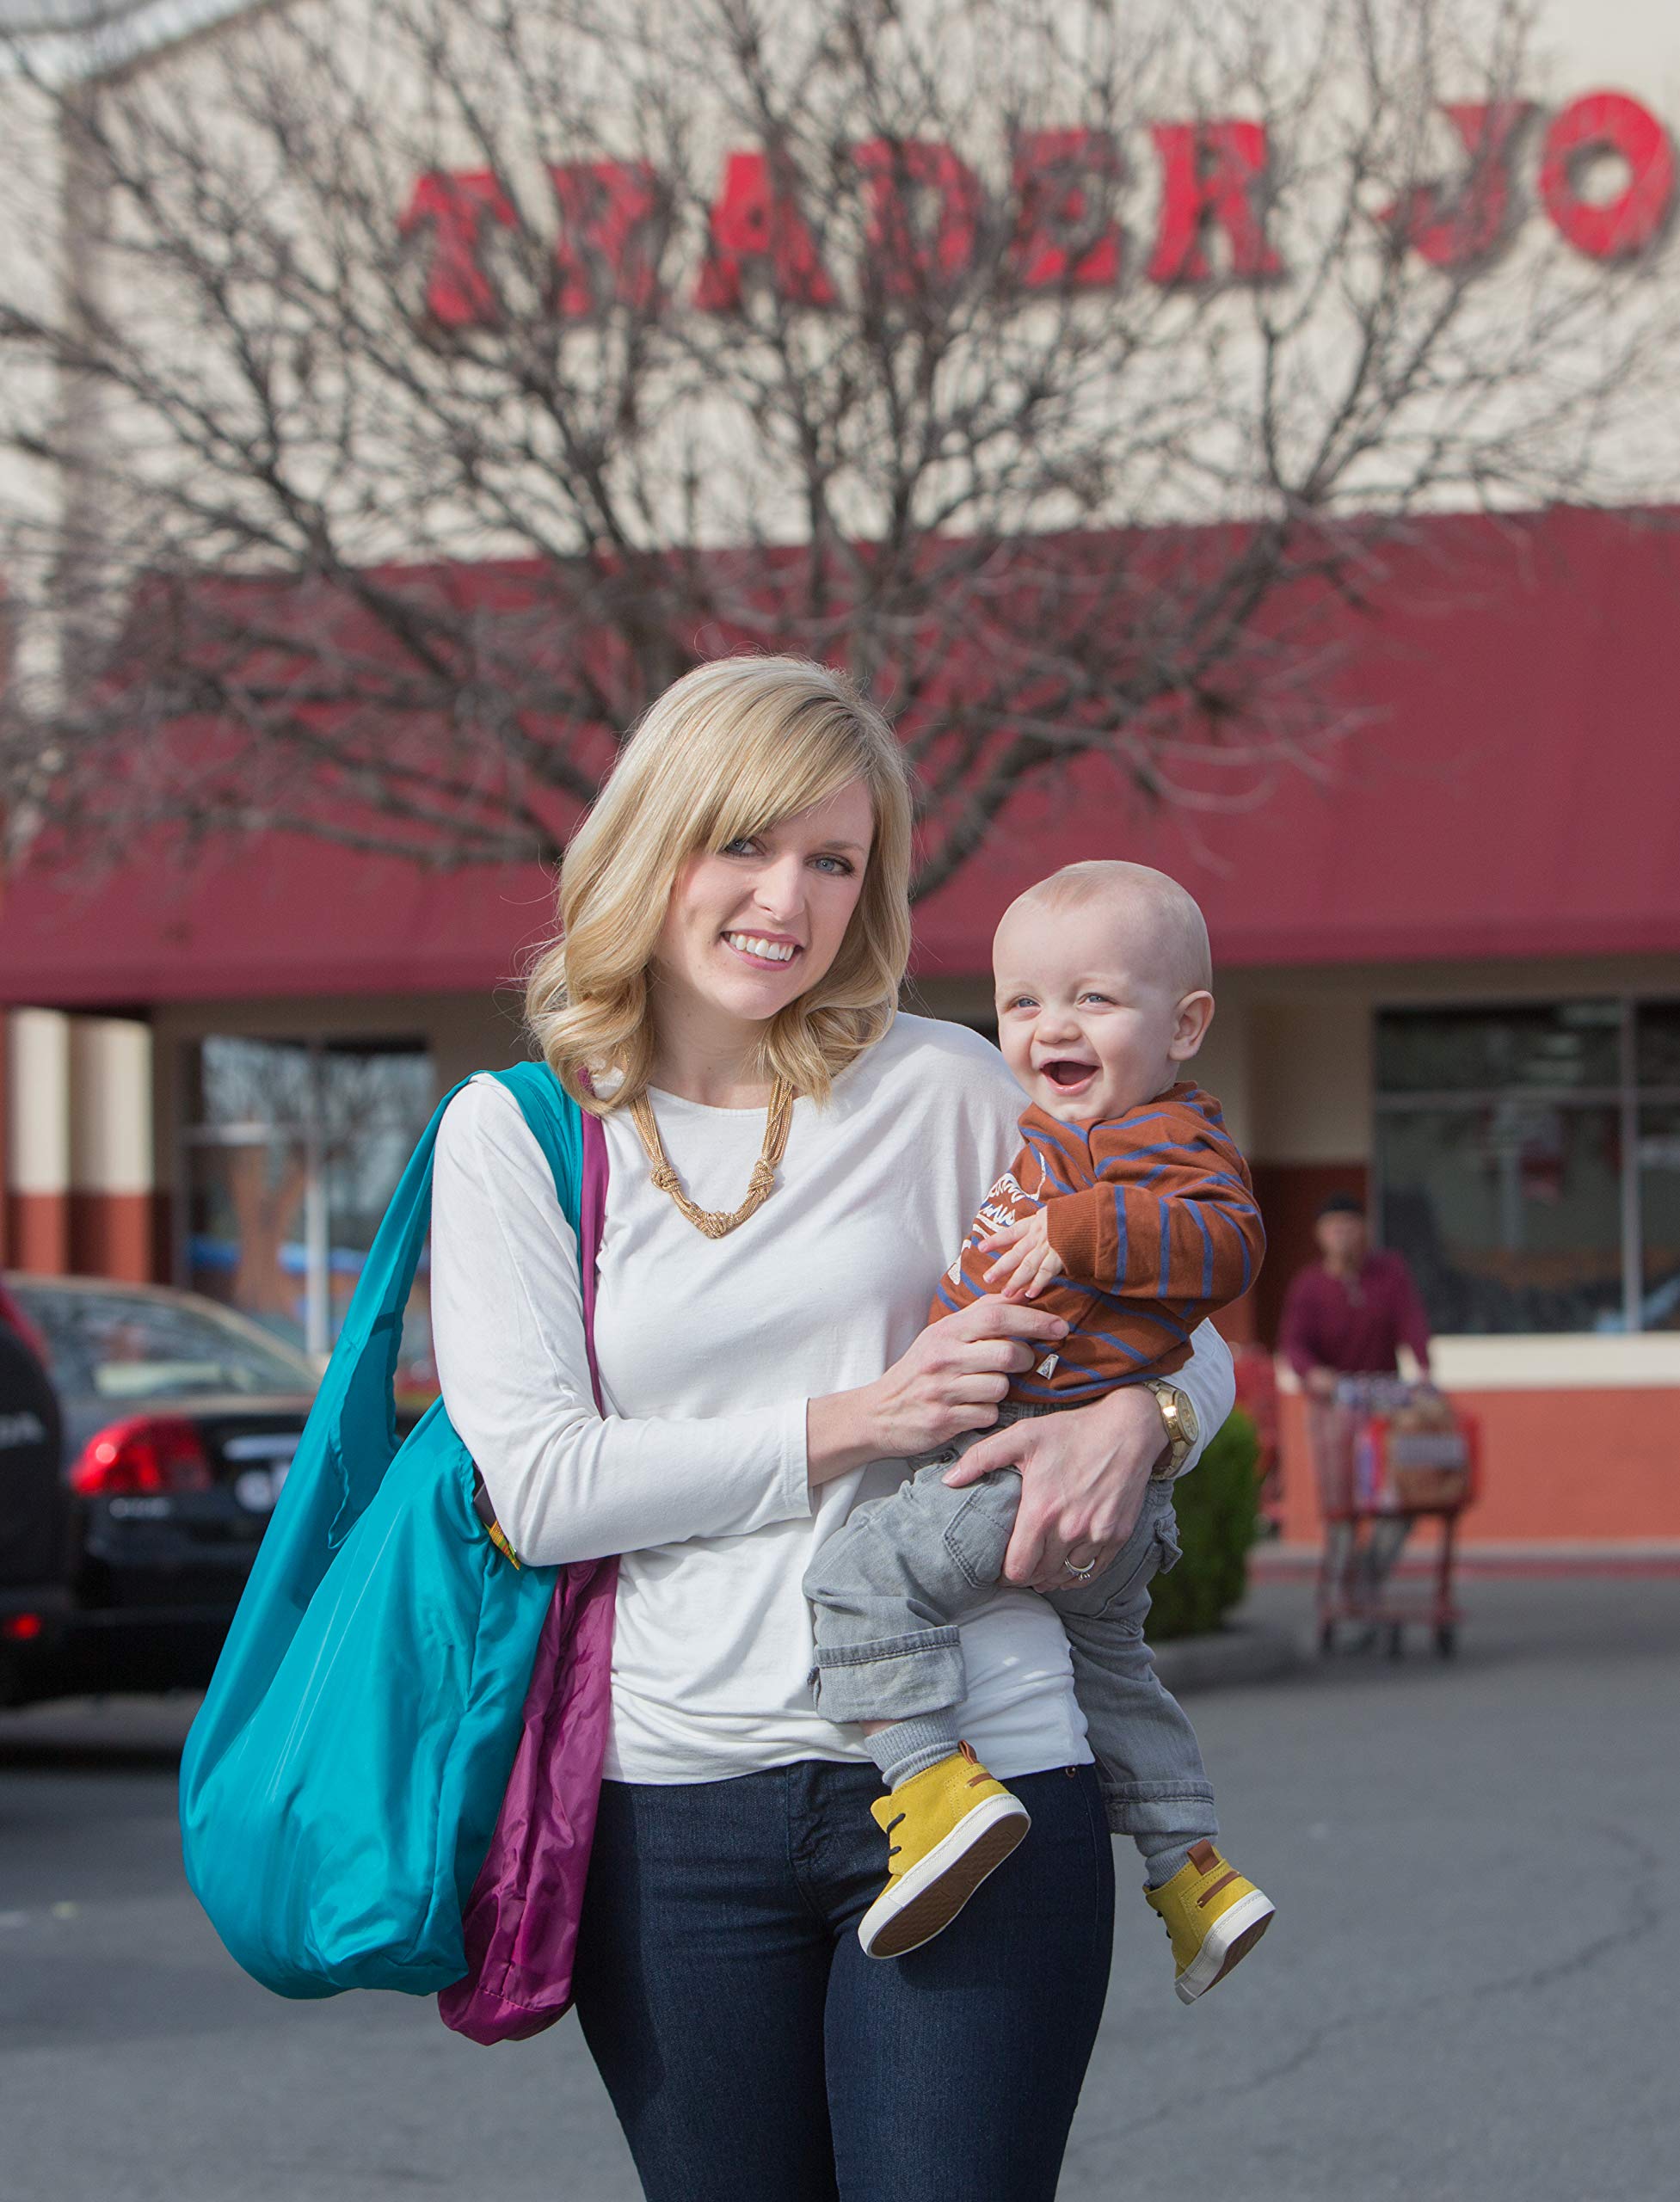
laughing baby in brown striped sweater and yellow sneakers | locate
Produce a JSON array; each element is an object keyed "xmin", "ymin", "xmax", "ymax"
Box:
[{"xmin": 806, "ymin": 864, "xmax": 1272, "ymax": 2004}]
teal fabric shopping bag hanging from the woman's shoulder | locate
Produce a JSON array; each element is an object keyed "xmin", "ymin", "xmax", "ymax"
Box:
[{"xmin": 181, "ymin": 1063, "xmax": 583, "ymax": 1997}]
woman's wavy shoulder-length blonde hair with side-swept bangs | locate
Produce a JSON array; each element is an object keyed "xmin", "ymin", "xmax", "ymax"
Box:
[{"xmin": 524, "ymin": 656, "xmax": 909, "ymax": 1116}]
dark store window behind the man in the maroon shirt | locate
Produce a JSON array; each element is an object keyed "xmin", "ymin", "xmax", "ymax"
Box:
[{"xmin": 1374, "ymin": 1000, "xmax": 1680, "ymax": 1334}]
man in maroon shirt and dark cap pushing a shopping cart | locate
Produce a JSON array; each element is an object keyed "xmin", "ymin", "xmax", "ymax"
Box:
[{"xmin": 1279, "ymin": 1194, "xmax": 1429, "ymax": 1590}]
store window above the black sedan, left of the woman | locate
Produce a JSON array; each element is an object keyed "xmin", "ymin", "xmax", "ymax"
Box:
[{"xmin": 176, "ymin": 1037, "xmax": 436, "ymax": 1356}]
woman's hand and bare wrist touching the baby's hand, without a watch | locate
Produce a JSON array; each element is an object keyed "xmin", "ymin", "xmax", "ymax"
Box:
[{"xmin": 806, "ymin": 1295, "xmax": 1068, "ymax": 1484}]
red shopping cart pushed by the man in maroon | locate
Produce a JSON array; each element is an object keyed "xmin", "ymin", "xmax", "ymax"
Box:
[{"xmin": 1308, "ymin": 1376, "xmax": 1480, "ymax": 1658}]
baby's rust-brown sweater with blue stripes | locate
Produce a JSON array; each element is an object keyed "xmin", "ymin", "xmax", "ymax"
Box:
[{"xmin": 927, "ymin": 1086, "xmax": 1266, "ymax": 1407}]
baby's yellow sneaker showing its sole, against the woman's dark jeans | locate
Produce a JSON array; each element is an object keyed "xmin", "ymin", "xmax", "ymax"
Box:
[{"xmin": 857, "ymin": 1744, "xmax": 1032, "ymax": 1958}]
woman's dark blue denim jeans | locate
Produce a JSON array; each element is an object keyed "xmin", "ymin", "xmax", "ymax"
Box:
[{"xmin": 577, "ymin": 1759, "xmax": 1114, "ymax": 2202}]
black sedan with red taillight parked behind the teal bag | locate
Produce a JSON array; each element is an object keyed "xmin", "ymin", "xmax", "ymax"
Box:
[{"xmin": 0, "ymin": 1275, "xmax": 317, "ymax": 1702}]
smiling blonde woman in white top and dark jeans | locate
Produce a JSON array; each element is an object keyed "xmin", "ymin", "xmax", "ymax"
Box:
[{"xmin": 432, "ymin": 658, "xmax": 1231, "ymax": 2202}]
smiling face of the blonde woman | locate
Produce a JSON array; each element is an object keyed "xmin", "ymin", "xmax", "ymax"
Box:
[{"xmin": 654, "ymin": 779, "xmax": 874, "ymax": 1024}]
